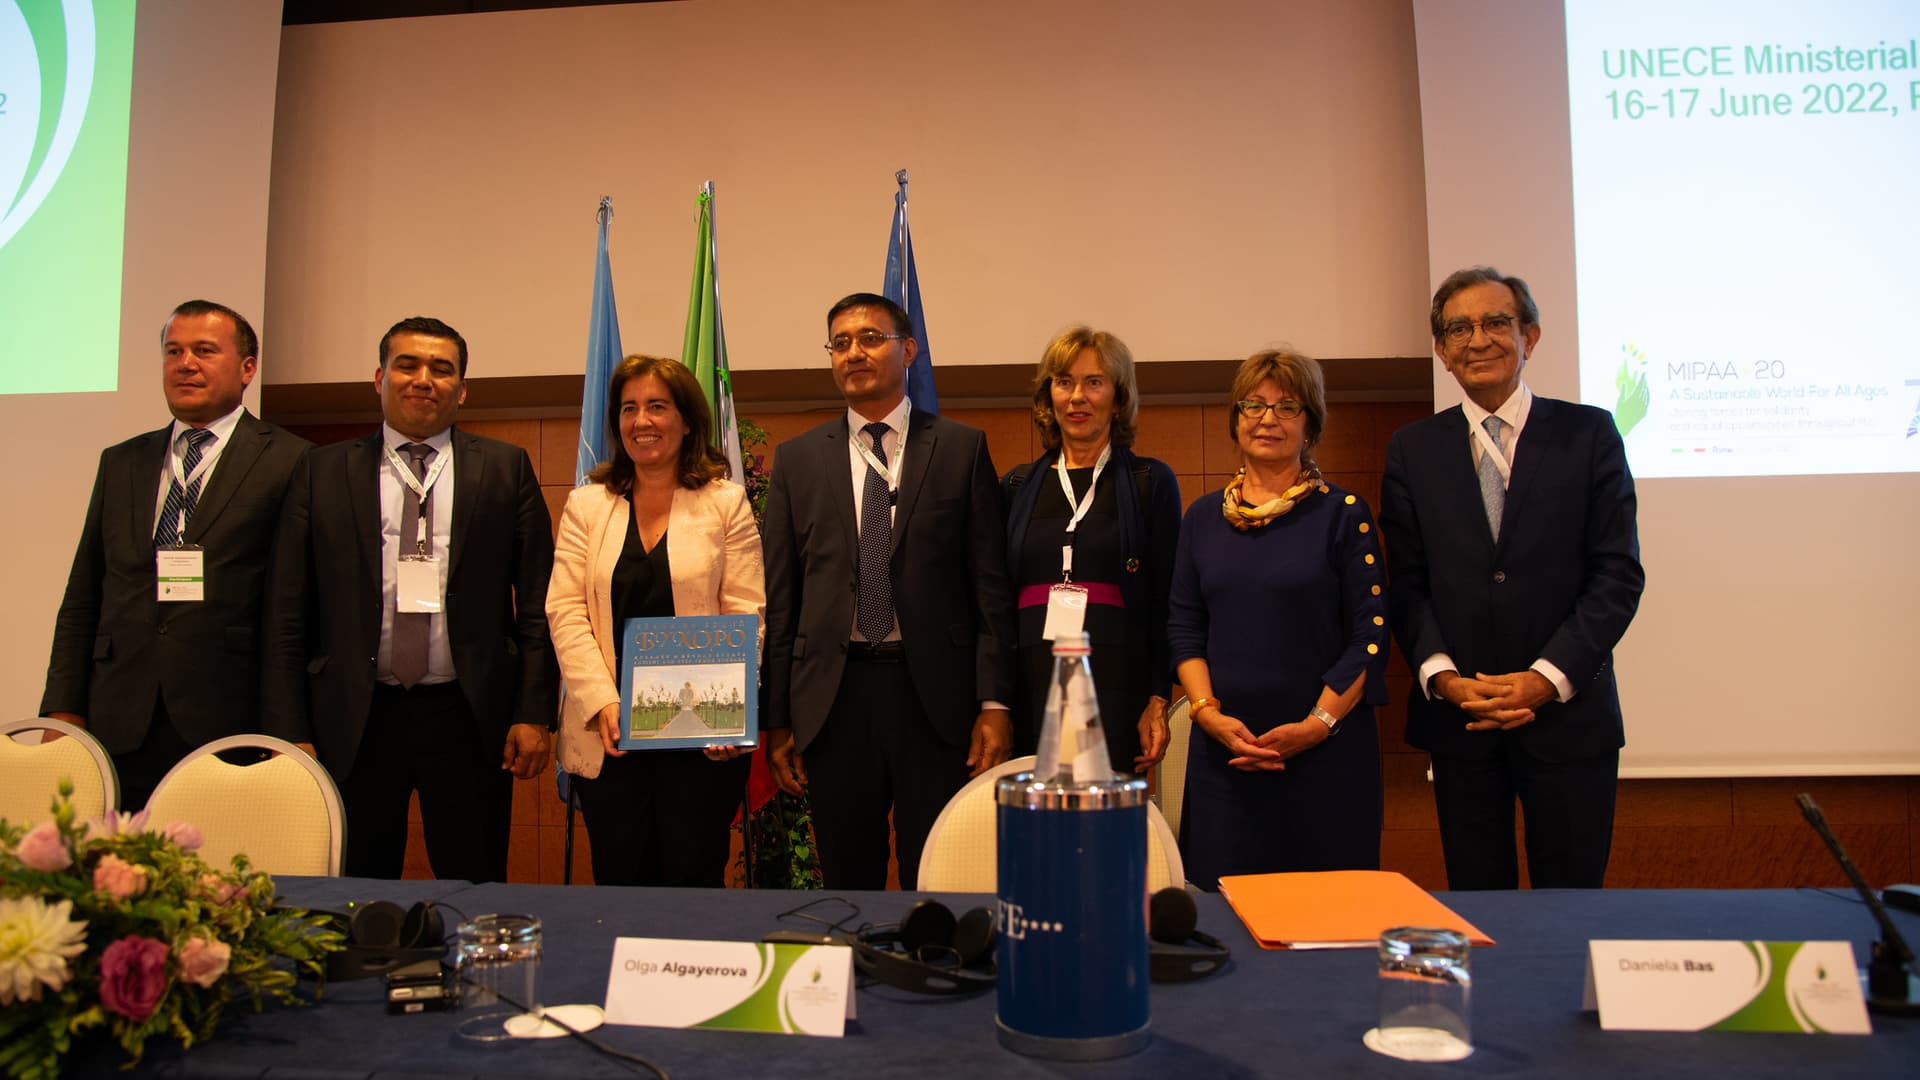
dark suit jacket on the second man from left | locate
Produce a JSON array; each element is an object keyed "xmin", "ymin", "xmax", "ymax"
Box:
[{"xmin": 267, "ymin": 429, "xmax": 559, "ymax": 778}]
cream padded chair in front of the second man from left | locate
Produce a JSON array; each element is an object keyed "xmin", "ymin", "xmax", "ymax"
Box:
[{"xmin": 146, "ymin": 734, "xmax": 346, "ymax": 878}]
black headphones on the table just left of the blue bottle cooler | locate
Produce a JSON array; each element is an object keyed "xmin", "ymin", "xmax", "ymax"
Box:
[{"xmin": 852, "ymin": 899, "xmax": 998, "ymax": 995}]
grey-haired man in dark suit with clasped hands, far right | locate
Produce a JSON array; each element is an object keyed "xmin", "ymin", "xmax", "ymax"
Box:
[{"xmin": 1380, "ymin": 267, "xmax": 1645, "ymax": 890}]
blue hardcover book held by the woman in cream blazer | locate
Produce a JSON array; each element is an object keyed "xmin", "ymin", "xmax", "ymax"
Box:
[{"xmin": 620, "ymin": 615, "xmax": 760, "ymax": 749}]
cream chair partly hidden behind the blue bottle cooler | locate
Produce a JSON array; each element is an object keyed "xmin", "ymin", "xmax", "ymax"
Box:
[{"xmin": 918, "ymin": 755, "xmax": 1187, "ymax": 892}]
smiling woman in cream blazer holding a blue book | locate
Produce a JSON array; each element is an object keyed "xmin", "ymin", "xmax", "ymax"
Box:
[{"xmin": 547, "ymin": 356, "xmax": 766, "ymax": 886}]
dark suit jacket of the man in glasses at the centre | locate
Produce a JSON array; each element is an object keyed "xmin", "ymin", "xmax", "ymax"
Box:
[{"xmin": 760, "ymin": 409, "xmax": 1014, "ymax": 751}]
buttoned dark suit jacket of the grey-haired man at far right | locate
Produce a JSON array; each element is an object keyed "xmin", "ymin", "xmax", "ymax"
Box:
[{"xmin": 1380, "ymin": 396, "xmax": 1645, "ymax": 761}]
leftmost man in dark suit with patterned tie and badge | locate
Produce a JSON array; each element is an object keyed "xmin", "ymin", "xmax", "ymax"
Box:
[{"xmin": 40, "ymin": 300, "xmax": 309, "ymax": 809}]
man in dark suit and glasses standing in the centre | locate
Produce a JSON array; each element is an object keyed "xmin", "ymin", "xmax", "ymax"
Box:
[{"xmin": 762, "ymin": 292, "xmax": 1014, "ymax": 888}]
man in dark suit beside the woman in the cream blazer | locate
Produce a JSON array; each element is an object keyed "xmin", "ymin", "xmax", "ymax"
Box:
[{"xmin": 267, "ymin": 317, "xmax": 559, "ymax": 882}]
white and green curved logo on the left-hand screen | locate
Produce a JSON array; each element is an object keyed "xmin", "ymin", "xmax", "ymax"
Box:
[{"xmin": 0, "ymin": 0, "xmax": 96, "ymax": 248}]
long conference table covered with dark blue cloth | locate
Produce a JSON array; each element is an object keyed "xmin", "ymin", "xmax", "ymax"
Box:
[{"xmin": 112, "ymin": 878, "xmax": 1920, "ymax": 1080}]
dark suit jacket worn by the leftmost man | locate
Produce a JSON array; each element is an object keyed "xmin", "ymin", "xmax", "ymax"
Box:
[{"xmin": 40, "ymin": 413, "xmax": 311, "ymax": 753}]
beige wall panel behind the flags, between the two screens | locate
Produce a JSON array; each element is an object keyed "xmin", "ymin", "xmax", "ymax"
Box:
[{"xmin": 267, "ymin": 0, "xmax": 1427, "ymax": 382}]
